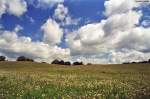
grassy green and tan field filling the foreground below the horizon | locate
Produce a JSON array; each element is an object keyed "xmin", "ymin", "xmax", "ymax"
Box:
[{"xmin": 0, "ymin": 62, "xmax": 150, "ymax": 99}]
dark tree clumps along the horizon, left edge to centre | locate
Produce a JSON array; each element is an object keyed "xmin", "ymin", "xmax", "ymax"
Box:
[{"xmin": 0, "ymin": 56, "xmax": 83, "ymax": 65}]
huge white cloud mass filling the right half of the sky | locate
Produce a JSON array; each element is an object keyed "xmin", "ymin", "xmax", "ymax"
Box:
[{"xmin": 66, "ymin": 0, "xmax": 150, "ymax": 63}]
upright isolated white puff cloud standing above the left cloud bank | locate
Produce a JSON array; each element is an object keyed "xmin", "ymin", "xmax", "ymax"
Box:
[{"xmin": 41, "ymin": 18, "xmax": 63, "ymax": 45}]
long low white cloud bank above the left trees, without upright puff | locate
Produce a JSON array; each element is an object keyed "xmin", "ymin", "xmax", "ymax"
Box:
[{"xmin": 0, "ymin": 26, "xmax": 70, "ymax": 62}]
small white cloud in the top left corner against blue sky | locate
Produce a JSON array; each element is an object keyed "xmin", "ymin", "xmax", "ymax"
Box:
[{"xmin": 0, "ymin": 0, "xmax": 27, "ymax": 17}]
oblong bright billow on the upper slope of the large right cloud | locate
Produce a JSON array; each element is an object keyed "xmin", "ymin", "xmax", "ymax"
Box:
[{"xmin": 104, "ymin": 11, "xmax": 142, "ymax": 33}]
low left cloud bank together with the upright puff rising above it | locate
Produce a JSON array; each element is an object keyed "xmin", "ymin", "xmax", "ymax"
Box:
[{"xmin": 0, "ymin": 19, "xmax": 70, "ymax": 62}]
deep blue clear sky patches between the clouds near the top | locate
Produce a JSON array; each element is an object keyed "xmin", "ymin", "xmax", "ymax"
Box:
[{"xmin": 0, "ymin": 0, "xmax": 104, "ymax": 41}]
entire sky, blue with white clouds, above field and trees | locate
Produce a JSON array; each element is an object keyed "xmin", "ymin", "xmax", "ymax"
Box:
[{"xmin": 0, "ymin": 0, "xmax": 150, "ymax": 64}]
